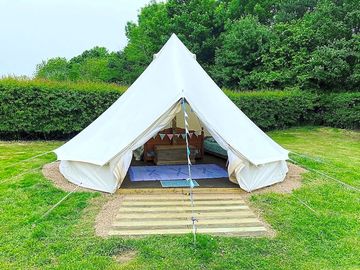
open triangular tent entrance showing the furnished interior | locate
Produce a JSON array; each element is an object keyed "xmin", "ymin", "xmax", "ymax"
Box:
[{"xmin": 120, "ymin": 99, "xmax": 238, "ymax": 189}]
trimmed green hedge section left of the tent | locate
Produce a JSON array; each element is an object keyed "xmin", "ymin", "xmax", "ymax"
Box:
[{"xmin": 0, "ymin": 78, "xmax": 124, "ymax": 139}]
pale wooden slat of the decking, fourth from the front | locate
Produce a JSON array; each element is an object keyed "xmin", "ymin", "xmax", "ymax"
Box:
[{"xmin": 119, "ymin": 205, "xmax": 249, "ymax": 213}]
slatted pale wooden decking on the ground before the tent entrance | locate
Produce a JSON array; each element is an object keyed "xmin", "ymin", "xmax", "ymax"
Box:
[{"xmin": 109, "ymin": 188, "xmax": 267, "ymax": 236}]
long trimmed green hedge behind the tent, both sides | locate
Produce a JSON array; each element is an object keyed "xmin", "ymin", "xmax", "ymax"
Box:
[{"xmin": 0, "ymin": 78, "xmax": 360, "ymax": 139}]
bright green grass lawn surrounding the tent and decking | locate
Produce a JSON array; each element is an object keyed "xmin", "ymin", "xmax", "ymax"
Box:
[{"xmin": 0, "ymin": 127, "xmax": 360, "ymax": 270}]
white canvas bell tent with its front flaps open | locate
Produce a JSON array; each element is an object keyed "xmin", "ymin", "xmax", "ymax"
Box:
[{"xmin": 55, "ymin": 34, "xmax": 288, "ymax": 193}]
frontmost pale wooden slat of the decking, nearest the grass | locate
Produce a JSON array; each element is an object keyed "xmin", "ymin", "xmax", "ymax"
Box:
[{"xmin": 109, "ymin": 226, "xmax": 266, "ymax": 236}]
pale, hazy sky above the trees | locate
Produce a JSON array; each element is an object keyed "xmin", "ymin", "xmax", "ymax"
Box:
[{"xmin": 0, "ymin": 0, "xmax": 150, "ymax": 77}]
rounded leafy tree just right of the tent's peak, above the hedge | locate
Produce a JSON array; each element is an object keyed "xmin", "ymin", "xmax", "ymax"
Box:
[{"xmin": 212, "ymin": 16, "xmax": 271, "ymax": 89}]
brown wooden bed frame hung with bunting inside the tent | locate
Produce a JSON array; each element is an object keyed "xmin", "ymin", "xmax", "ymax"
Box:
[{"xmin": 144, "ymin": 127, "xmax": 204, "ymax": 162}]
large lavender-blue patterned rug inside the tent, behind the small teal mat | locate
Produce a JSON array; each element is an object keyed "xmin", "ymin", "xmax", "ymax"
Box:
[{"xmin": 129, "ymin": 164, "xmax": 228, "ymax": 182}]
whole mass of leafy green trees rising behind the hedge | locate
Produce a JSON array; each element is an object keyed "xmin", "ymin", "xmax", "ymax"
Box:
[{"xmin": 36, "ymin": 0, "xmax": 360, "ymax": 91}]
